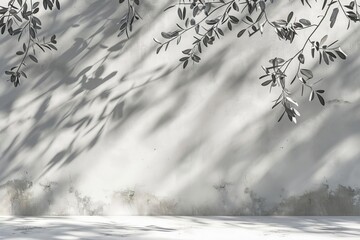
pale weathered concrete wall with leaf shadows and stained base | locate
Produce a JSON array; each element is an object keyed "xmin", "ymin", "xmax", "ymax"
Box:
[{"xmin": 0, "ymin": 0, "xmax": 360, "ymax": 215}]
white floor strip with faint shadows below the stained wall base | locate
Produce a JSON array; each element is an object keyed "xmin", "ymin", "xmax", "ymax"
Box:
[{"xmin": 0, "ymin": 216, "xmax": 360, "ymax": 240}]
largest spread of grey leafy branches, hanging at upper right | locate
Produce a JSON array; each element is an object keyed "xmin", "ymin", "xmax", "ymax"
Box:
[{"xmin": 154, "ymin": 0, "xmax": 354, "ymax": 123}]
